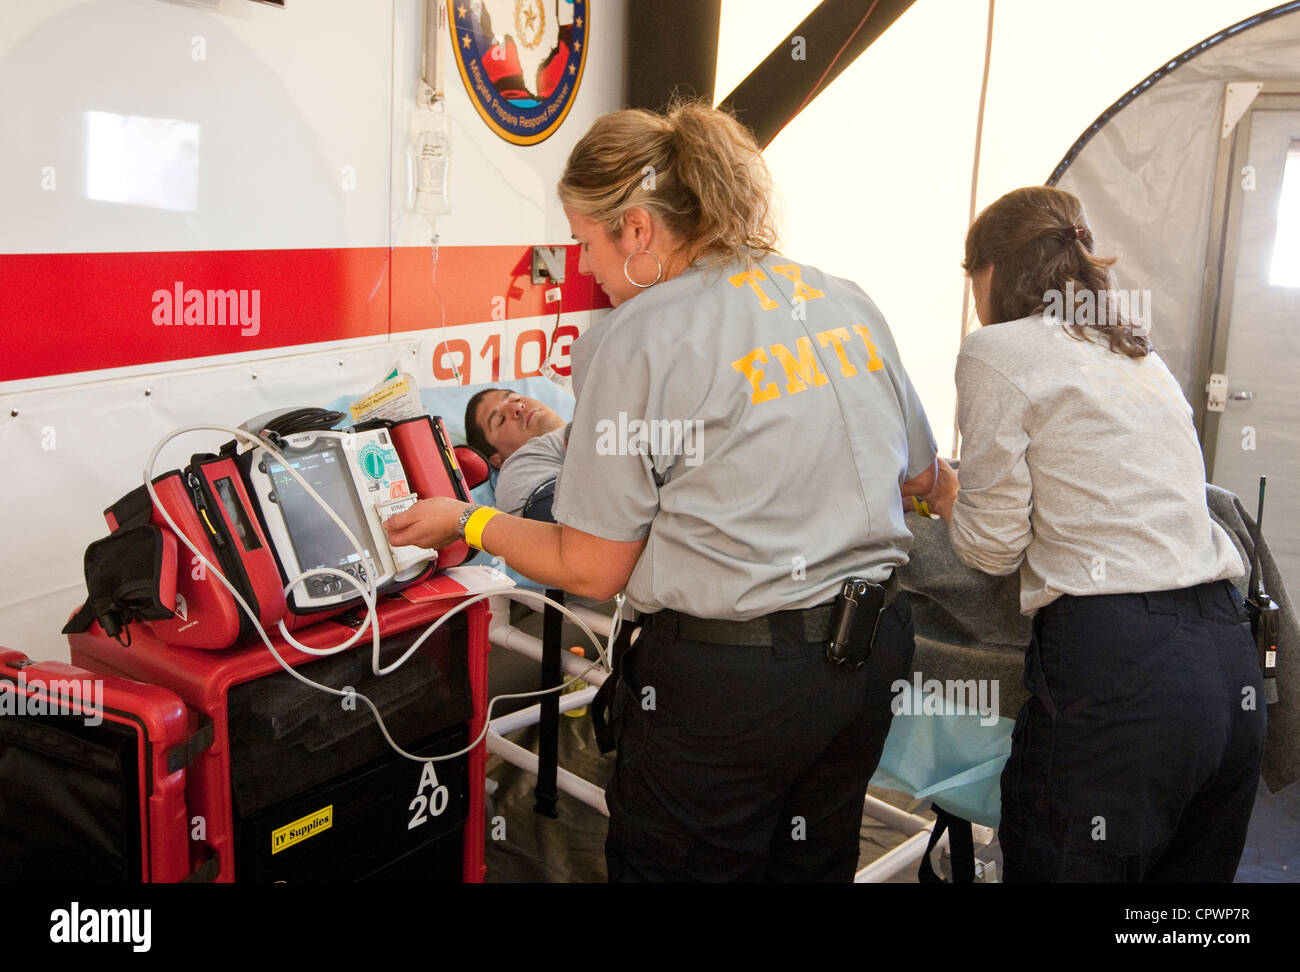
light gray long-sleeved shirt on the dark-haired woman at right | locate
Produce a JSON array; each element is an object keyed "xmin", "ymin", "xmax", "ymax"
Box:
[{"xmin": 949, "ymin": 316, "xmax": 1244, "ymax": 615}]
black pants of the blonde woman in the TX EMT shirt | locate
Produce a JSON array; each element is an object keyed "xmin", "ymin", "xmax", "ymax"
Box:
[{"xmin": 606, "ymin": 596, "xmax": 914, "ymax": 881}]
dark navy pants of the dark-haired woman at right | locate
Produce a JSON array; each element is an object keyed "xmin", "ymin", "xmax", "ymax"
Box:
[{"xmin": 998, "ymin": 581, "xmax": 1265, "ymax": 882}]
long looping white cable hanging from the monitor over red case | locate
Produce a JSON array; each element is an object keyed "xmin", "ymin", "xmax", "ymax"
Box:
[{"xmin": 144, "ymin": 425, "xmax": 621, "ymax": 763}]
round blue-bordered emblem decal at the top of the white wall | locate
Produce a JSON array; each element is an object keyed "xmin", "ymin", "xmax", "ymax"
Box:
[{"xmin": 450, "ymin": 0, "xmax": 588, "ymax": 146}]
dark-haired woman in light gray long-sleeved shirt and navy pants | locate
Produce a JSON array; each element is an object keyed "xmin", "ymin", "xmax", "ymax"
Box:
[{"xmin": 933, "ymin": 187, "xmax": 1265, "ymax": 881}]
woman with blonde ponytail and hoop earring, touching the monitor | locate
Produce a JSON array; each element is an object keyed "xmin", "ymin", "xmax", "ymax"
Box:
[{"xmin": 389, "ymin": 104, "xmax": 935, "ymax": 881}]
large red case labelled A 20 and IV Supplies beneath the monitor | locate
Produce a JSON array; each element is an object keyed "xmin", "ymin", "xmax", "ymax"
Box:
[{"xmin": 69, "ymin": 577, "xmax": 490, "ymax": 882}]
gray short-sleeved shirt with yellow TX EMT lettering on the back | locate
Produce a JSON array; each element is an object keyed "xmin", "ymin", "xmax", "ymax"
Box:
[{"xmin": 554, "ymin": 256, "xmax": 935, "ymax": 620}]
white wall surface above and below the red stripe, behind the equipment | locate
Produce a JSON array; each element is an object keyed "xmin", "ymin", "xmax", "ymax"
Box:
[{"xmin": 0, "ymin": 0, "xmax": 625, "ymax": 659}]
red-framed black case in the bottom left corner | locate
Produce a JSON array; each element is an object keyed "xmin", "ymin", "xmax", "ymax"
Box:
[{"xmin": 0, "ymin": 648, "xmax": 197, "ymax": 884}]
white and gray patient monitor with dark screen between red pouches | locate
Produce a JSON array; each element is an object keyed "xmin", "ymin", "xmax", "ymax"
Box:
[{"xmin": 248, "ymin": 429, "xmax": 438, "ymax": 611}]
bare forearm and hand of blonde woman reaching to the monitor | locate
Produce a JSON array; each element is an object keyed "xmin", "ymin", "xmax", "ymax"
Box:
[{"xmin": 384, "ymin": 496, "xmax": 646, "ymax": 600}]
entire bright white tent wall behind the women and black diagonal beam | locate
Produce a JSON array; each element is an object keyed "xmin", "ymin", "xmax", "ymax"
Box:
[{"xmin": 719, "ymin": 0, "xmax": 1268, "ymax": 454}]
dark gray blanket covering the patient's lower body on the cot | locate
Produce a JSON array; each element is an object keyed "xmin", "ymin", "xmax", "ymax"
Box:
[{"xmin": 898, "ymin": 485, "xmax": 1300, "ymax": 791}]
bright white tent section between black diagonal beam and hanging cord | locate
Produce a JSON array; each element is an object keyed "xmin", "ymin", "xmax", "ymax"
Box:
[{"xmin": 767, "ymin": 0, "xmax": 987, "ymax": 455}]
